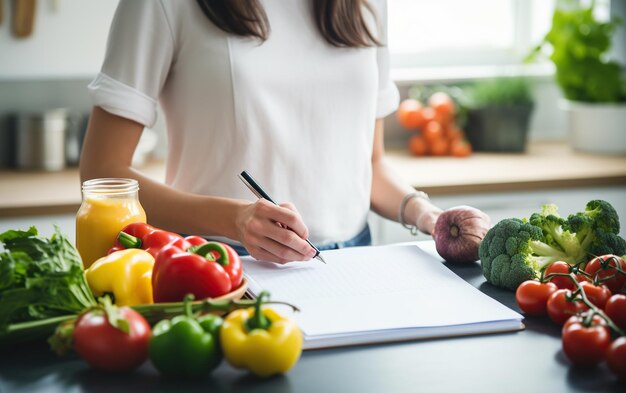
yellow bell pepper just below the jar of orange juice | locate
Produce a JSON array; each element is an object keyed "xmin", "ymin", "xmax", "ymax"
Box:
[{"xmin": 85, "ymin": 248, "xmax": 154, "ymax": 307}]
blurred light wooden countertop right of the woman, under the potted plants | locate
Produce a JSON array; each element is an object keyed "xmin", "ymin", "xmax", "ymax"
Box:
[{"xmin": 387, "ymin": 142, "xmax": 626, "ymax": 195}]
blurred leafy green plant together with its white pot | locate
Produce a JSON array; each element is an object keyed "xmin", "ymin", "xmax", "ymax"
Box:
[{"xmin": 529, "ymin": 0, "xmax": 626, "ymax": 154}]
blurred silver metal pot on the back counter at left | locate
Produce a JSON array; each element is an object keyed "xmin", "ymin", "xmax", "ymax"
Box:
[{"xmin": 15, "ymin": 109, "xmax": 69, "ymax": 171}]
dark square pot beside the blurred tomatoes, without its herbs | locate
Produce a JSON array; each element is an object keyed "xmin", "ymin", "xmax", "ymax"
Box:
[{"xmin": 465, "ymin": 105, "xmax": 533, "ymax": 152}]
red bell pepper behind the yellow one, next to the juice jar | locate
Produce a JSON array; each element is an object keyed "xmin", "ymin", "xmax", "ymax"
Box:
[{"xmin": 108, "ymin": 222, "xmax": 183, "ymax": 258}]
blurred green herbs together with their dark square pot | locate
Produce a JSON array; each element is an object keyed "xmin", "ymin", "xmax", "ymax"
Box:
[{"xmin": 463, "ymin": 77, "xmax": 533, "ymax": 152}]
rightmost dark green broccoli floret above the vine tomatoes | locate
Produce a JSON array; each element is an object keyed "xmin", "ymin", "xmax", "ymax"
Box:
[{"xmin": 566, "ymin": 200, "xmax": 626, "ymax": 258}]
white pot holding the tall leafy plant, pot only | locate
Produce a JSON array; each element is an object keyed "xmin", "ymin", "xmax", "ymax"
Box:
[{"xmin": 561, "ymin": 100, "xmax": 626, "ymax": 154}]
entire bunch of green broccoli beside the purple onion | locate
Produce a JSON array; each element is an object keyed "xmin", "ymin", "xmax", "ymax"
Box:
[{"xmin": 478, "ymin": 200, "xmax": 626, "ymax": 290}]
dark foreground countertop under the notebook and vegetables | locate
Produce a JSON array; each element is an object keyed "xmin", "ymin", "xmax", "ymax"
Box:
[{"xmin": 0, "ymin": 242, "xmax": 624, "ymax": 393}]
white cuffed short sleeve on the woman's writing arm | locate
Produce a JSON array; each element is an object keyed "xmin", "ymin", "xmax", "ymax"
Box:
[{"xmin": 88, "ymin": 0, "xmax": 174, "ymax": 127}]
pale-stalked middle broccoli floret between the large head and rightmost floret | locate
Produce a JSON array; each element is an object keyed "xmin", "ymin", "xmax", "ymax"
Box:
[{"xmin": 529, "ymin": 204, "xmax": 587, "ymax": 262}]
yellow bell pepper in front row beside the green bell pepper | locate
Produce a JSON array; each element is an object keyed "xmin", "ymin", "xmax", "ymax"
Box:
[{"xmin": 220, "ymin": 293, "xmax": 302, "ymax": 377}]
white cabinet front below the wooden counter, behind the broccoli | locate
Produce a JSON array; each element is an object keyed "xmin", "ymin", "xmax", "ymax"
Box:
[{"xmin": 370, "ymin": 186, "xmax": 626, "ymax": 244}]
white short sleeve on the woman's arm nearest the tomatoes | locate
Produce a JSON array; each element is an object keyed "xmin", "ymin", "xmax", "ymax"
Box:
[{"xmin": 376, "ymin": 1, "xmax": 400, "ymax": 119}]
